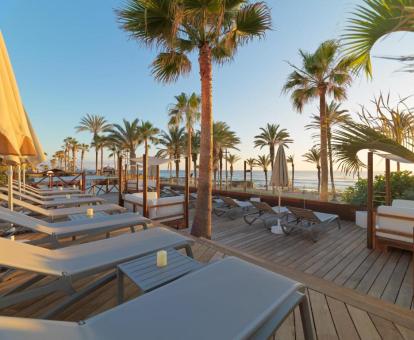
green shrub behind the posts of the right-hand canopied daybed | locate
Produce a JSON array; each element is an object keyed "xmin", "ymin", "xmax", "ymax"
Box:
[{"xmin": 342, "ymin": 171, "xmax": 414, "ymax": 206}]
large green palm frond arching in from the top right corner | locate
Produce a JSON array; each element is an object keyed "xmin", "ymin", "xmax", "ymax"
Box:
[{"xmin": 343, "ymin": 0, "xmax": 414, "ymax": 76}]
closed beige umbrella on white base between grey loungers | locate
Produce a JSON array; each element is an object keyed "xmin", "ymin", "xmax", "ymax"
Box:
[{"xmin": 270, "ymin": 145, "xmax": 289, "ymax": 234}]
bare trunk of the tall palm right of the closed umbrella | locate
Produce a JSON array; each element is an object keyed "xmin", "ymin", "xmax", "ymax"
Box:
[{"xmin": 319, "ymin": 87, "xmax": 328, "ymax": 201}]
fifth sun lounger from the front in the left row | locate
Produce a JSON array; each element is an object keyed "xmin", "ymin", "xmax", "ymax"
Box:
[{"xmin": 0, "ymin": 187, "xmax": 105, "ymax": 208}]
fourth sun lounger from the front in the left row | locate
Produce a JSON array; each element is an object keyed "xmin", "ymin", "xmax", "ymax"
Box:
[{"xmin": 0, "ymin": 194, "xmax": 126, "ymax": 221}]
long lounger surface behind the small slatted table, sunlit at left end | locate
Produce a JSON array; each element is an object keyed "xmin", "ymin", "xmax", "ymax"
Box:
[{"xmin": 0, "ymin": 227, "xmax": 188, "ymax": 276}]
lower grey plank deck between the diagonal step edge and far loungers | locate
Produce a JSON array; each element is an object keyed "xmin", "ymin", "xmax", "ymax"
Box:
[{"xmin": 207, "ymin": 211, "xmax": 413, "ymax": 309}]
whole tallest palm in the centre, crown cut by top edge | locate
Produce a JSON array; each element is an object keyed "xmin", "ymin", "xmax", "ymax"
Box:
[{"xmin": 118, "ymin": 0, "xmax": 271, "ymax": 238}]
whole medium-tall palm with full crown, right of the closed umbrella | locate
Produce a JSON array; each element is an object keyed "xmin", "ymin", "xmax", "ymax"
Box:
[{"xmin": 283, "ymin": 40, "xmax": 352, "ymax": 200}]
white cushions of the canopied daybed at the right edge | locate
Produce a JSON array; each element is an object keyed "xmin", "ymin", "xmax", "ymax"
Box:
[{"xmin": 376, "ymin": 205, "xmax": 414, "ymax": 243}]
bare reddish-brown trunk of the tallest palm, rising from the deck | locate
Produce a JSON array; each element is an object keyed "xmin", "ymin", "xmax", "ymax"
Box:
[{"xmin": 191, "ymin": 44, "xmax": 213, "ymax": 238}]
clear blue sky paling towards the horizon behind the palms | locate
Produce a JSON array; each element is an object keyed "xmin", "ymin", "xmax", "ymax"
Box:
[{"xmin": 0, "ymin": 0, "xmax": 414, "ymax": 170}]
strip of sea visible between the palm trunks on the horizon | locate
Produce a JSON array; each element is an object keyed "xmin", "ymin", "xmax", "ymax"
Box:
[{"xmin": 160, "ymin": 170, "xmax": 366, "ymax": 191}]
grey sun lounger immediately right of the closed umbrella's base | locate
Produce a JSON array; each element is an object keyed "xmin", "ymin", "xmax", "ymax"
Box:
[{"xmin": 282, "ymin": 207, "xmax": 341, "ymax": 242}]
